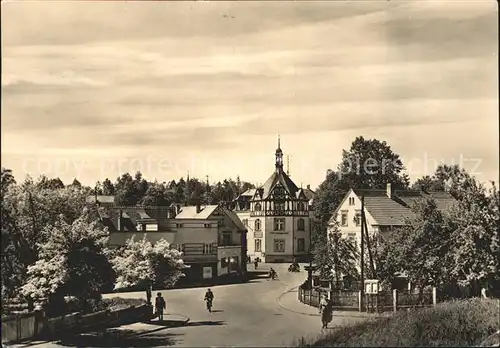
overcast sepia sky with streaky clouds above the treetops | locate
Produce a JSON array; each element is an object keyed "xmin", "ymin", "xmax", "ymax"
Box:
[{"xmin": 2, "ymin": 0, "xmax": 499, "ymax": 187}]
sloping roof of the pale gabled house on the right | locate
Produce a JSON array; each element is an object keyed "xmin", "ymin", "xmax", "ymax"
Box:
[{"xmin": 353, "ymin": 189, "xmax": 455, "ymax": 226}]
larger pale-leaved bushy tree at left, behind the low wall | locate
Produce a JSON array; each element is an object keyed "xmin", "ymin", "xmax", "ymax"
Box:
[{"xmin": 22, "ymin": 209, "xmax": 115, "ymax": 316}]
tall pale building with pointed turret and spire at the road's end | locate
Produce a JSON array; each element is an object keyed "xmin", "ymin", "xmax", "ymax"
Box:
[{"xmin": 233, "ymin": 139, "xmax": 314, "ymax": 262}]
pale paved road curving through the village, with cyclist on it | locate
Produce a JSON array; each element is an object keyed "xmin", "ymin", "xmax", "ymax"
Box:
[{"xmin": 12, "ymin": 264, "xmax": 364, "ymax": 348}]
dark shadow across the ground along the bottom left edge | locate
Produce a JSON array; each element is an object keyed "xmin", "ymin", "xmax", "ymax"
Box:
[{"xmin": 53, "ymin": 327, "xmax": 180, "ymax": 348}]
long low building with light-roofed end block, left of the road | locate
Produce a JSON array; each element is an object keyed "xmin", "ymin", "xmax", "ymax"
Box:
[{"xmin": 93, "ymin": 204, "xmax": 247, "ymax": 281}]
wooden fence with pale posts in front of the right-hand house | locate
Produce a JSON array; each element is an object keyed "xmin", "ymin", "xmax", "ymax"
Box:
[{"xmin": 298, "ymin": 287, "xmax": 437, "ymax": 313}]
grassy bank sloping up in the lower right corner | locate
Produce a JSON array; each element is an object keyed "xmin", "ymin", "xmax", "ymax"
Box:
[{"xmin": 296, "ymin": 299, "xmax": 500, "ymax": 347}]
